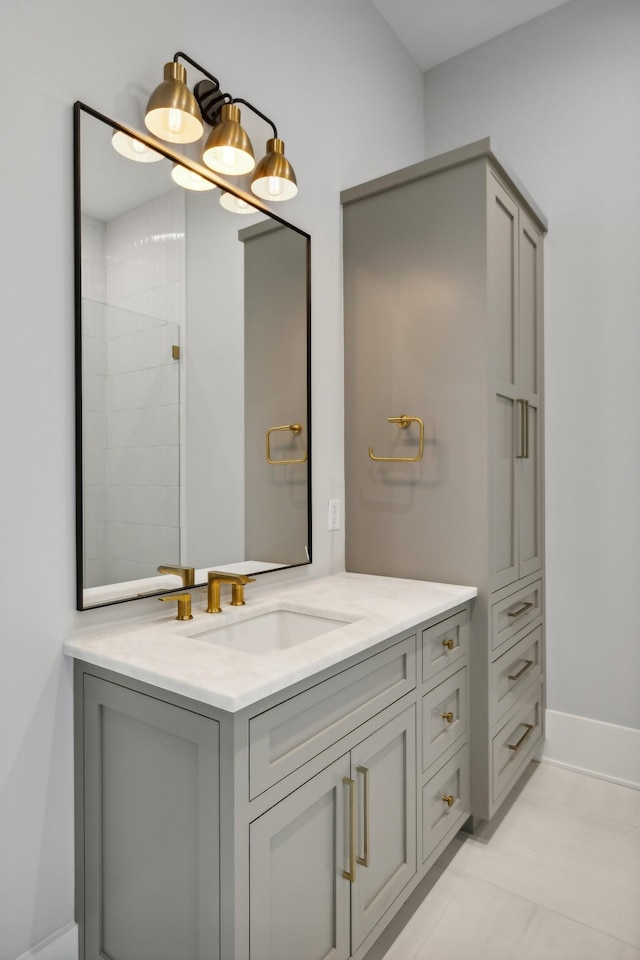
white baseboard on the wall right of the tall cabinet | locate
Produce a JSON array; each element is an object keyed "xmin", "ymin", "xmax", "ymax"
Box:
[{"xmin": 540, "ymin": 710, "xmax": 640, "ymax": 790}]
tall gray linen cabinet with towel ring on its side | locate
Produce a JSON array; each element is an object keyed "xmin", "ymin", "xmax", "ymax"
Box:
[{"xmin": 342, "ymin": 140, "xmax": 546, "ymax": 819}]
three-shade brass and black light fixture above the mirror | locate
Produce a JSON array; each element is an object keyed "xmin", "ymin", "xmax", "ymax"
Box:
[{"xmin": 145, "ymin": 51, "xmax": 298, "ymax": 206}]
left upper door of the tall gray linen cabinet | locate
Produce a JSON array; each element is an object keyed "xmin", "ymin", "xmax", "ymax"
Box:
[{"xmin": 487, "ymin": 173, "xmax": 518, "ymax": 590}]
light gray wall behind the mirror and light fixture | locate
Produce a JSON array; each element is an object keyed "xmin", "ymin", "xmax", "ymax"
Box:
[{"xmin": 0, "ymin": 0, "xmax": 424, "ymax": 960}]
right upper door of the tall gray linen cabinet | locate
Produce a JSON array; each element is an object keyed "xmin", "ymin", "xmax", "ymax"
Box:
[{"xmin": 517, "ymin": 210, "xmax": 543, "ymax": 577}]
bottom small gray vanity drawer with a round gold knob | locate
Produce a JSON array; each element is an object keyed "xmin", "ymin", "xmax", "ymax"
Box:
[{"xmin": 422, "ymin": 745, "xmax": 470, "ymax": 863}]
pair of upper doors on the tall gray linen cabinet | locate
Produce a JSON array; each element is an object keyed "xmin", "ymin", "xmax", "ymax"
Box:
[{"xmin": 487, "ymin": 174, "xmax": 542, "ymax": 591}]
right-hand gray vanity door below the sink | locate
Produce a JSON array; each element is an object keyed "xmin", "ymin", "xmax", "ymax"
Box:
[{"xmin": 351, "ymin": 706, "xmax": 417, "ymax": 953}]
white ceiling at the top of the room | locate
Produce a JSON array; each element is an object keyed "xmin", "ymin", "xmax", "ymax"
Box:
[{"xmin": 372, "ymin": 0, "xmax": 567, "ymax": 71}]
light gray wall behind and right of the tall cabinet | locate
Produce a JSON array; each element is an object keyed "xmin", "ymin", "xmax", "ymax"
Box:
[{"xmin": 425, "ymin": 0, "xmax": 640, "ymax": 728}]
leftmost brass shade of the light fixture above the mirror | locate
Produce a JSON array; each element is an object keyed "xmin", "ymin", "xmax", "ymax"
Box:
[{"xmin": 144, "ymin": 61, "xmax": 204, "ymax": 143}]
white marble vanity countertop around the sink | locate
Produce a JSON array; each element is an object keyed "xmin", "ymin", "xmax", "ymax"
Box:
[{"xmin": 64, "ymin": 573, "xmax": 477, "ymax": 712}]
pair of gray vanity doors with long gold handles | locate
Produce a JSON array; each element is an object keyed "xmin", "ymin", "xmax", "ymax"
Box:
[{"xmin": 250, "ymin": 706, "xmax": 416, "ymax": 960}]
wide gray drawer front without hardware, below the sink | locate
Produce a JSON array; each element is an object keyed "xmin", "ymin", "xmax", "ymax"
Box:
[{"xmin": 249, "ymin": 635, "xmax": 416, "ymax": 799}]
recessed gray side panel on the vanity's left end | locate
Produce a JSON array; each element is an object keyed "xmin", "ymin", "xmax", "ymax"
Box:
[{"xmin": 80, "ymin": 675, "xmax": 220, "ymax": 960}]
